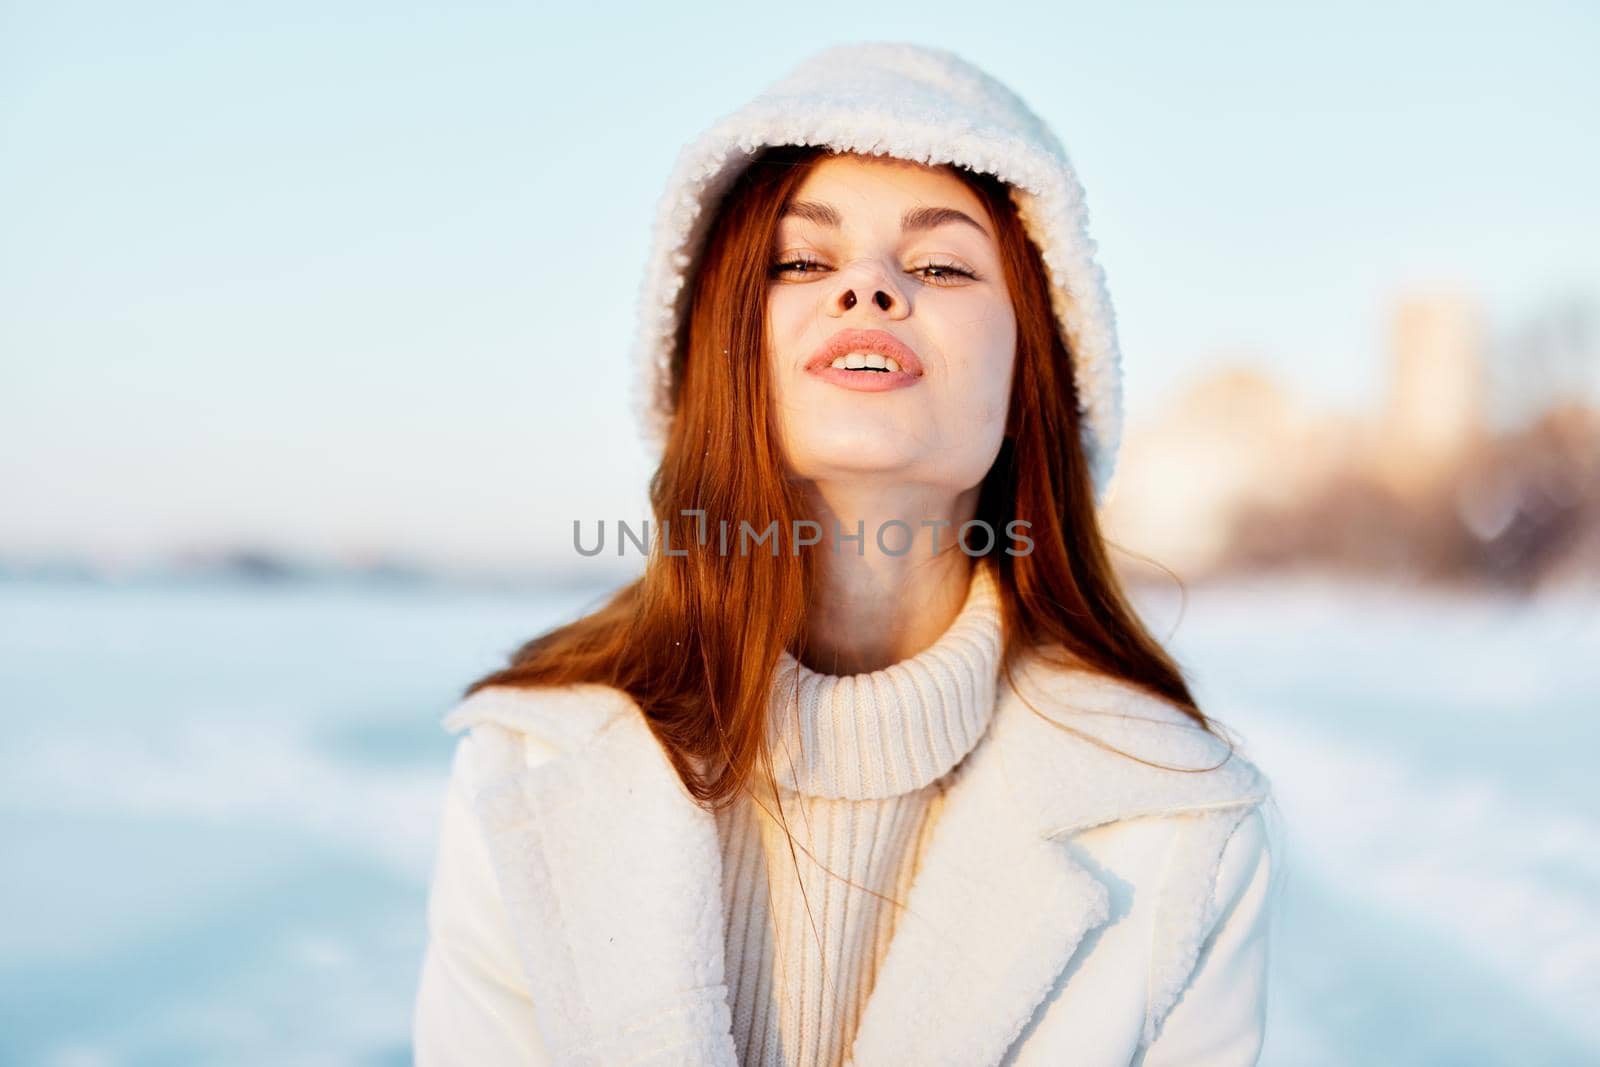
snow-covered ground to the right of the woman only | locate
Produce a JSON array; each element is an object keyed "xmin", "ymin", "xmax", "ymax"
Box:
[{"xmin": 1146, "ymin": 581, "xmax": 1600, "ymax": 1065}]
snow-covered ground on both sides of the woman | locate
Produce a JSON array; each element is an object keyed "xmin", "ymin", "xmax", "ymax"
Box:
[{"xmin": 0, "ymin": 581, "xmax": 1600, "ymax": 1067}]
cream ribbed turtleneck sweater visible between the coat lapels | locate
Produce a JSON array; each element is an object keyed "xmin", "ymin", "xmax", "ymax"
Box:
[{"xmin": 717, "ymin": 560, "xmax": 1000, "ymax": 1067}]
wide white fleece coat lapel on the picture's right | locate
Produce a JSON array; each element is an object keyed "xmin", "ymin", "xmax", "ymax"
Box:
[{"xmin": 850, "ymin": 657, "xmax": 1264, "ymax": 1067}]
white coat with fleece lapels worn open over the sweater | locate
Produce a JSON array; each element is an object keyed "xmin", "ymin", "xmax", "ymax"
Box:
[{"xmin": 414, "ymin": 646, "xmax": 1274, "ymax": 1067}]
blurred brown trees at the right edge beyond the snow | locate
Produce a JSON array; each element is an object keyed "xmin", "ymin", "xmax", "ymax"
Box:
[{"xmin": 1210, "ymin": 294, "xmax": 1600, "ymax": 592}]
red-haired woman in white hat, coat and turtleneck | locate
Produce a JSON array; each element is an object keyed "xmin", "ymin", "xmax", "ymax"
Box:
[{"xmin": 416, "ymin": 45, "xmax": 1270, "ymax": 1067}]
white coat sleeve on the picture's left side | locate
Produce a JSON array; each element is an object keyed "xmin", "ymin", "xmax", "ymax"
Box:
[{"xmin": 413, "ymin": 733, "xmax": 552, "ymax": 1067}]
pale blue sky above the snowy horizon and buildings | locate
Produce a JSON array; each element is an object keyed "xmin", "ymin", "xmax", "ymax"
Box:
[{"xmin": 0, "ymin": 0, "xmax": 1600, "ymax": 575}]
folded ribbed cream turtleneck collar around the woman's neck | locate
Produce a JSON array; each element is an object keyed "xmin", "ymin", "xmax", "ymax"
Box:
[{"xmin": 773, "ymin": 560, "xmax": 1000, "ymax": 800}]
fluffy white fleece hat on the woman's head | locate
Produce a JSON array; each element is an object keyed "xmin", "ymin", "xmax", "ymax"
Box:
[{"xmin": 635, "ymin": 42, "xmax": 1122, "ymax": 501}]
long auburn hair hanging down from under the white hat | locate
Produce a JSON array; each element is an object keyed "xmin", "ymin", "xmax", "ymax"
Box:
[{"xmin": 466, "ymin": 146, "xmax": 1218, "ymax": 809}]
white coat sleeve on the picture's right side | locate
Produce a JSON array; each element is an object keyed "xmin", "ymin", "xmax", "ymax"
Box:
[{"xmin": 1133, "ymin": 808, "xmax": 1272, "ymax": 1067}]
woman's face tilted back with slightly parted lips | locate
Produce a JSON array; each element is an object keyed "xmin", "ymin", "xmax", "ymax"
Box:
[{"xmin": 766, "ymin": 155, "xmax": 1016, "ymax": 493}]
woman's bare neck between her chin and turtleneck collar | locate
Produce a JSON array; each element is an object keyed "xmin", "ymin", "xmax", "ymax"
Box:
[{"xmin": 800, "ymin": 486, "xmax": 978, "ymax": 675}]
